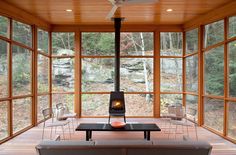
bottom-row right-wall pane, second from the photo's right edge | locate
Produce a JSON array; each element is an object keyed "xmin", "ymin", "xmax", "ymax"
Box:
[{"xmin": 204, "ymin": 97, "xmax": 224, "ymax": 133}]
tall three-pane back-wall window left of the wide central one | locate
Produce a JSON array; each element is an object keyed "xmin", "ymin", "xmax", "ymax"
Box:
[{"xmin": 51, "ymin": 32, "xmax": 75, "ymax": 110}]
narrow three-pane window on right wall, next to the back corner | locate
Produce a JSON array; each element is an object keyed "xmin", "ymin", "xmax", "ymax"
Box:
[{"xmin": 184, "ymin": 29, "xmax": 199, "ymax": 121}]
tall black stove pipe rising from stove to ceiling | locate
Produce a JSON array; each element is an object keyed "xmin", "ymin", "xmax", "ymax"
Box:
[{"xmin": 114, "ymin": 18, "xmax": 122, "ymax": 92}]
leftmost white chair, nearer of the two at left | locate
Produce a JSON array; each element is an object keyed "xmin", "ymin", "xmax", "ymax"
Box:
[{"xmin": 42, "ymin": 108, "xmax": 71, "ymax": 139}]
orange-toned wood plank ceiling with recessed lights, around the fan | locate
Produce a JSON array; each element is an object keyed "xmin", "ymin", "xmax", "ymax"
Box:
[{"xmin": 2, "ymin": 0, "xmax": 233, "ymax": 25}]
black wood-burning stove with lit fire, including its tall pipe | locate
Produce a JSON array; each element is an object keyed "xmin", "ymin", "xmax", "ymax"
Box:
[{"xmin": 108, "ymin": 18, "xmax": 126, "ymax": 123}]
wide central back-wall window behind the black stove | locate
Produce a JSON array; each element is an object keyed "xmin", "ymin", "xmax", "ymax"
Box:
[{"xmin": 81, "ymin": 32, "xmax": 154, "ymax": 116}]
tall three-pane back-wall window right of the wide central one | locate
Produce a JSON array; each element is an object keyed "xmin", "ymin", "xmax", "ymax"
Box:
[{"xmin": 160, "ymin": 32, "xmax": 183, "ymax": 115}]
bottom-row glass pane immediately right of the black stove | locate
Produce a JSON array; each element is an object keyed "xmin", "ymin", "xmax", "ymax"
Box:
[{"xmin": 125, "ymin": 94, "xmax": 153, "ymax": 116}]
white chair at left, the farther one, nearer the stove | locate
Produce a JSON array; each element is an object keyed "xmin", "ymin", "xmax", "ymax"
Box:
[{"xmin": 56, "ymin": 103, "xmax": 78, "ymax": 131}]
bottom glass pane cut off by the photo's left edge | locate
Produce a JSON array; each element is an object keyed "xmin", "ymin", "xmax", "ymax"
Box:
[{"xmin": 0, "ymin": 101, "xmax": 9, "ymax": 140}]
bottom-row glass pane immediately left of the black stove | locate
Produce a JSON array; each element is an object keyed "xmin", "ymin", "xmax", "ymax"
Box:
[{"xmin": 81, "ymin": 94, "xmax": 110, "ymax": 116}]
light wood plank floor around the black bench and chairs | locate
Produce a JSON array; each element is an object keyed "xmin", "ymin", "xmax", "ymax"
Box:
[{"xmin": 0, "ymin": 118, "xmax": 236, "ymax": 155}]
